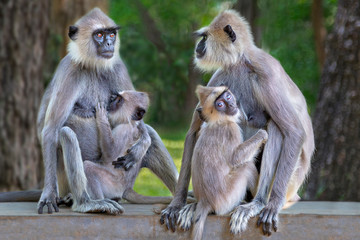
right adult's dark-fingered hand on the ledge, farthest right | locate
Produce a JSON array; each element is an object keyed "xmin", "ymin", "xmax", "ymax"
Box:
[{"xmin": 257, "ymin": 202, "xmax": 279, "ymax": 236}]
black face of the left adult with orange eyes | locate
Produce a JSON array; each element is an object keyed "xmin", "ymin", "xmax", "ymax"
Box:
[{"xmin": 93, "ymin": 27, "xmax": 118, "ymax": 58}]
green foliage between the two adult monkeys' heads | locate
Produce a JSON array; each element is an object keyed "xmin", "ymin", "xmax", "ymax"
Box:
[{"xmin": 110, "ymin": 0, "xmax": 219, "ymax": 123}]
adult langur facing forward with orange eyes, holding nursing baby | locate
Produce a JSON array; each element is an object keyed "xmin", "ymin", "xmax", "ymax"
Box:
[{"xmin": 37, "ymin": 8, "xmax": 178, "ymax": 214}]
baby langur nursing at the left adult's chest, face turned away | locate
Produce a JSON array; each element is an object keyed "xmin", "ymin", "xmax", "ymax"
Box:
[{"xmin": 75, "ymin": 90, "xmax": 172, "ymax": 208}]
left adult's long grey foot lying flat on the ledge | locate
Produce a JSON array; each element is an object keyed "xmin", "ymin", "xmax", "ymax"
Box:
[{"xmin": 72, "ymin": 199, "xmax": 124, "ymax": 215}]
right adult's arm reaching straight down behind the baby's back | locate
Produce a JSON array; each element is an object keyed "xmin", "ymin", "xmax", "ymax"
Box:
[{"xmin": 160, "ymin": 111, "xmax": 202, "ymax": 232}]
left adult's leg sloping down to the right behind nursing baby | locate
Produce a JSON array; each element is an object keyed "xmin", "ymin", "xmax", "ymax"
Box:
[{"xmin": 143, "ymin": 125, "xmax": 179, "ymax": 194}]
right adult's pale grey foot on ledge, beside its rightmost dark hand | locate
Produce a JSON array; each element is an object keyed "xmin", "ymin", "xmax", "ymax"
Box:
[{"xmin": 230, "ymin": 200, "xmax": 265, "ymax": 234}]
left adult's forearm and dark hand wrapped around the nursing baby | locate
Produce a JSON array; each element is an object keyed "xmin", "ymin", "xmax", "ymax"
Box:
[{"xmin": 113, "ymin": 121, "xmax": 151, "ymax": 171}]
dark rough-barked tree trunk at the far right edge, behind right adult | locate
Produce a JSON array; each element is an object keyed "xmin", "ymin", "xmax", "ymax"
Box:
[{"xmin": 305, "ymin": 0, "xmax": 360, "ymax": 201}]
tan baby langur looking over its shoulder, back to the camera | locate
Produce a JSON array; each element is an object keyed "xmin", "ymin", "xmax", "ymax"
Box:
[{"xmin": 178, "ymin": 86, "xmax": 268, "ymax": 239}]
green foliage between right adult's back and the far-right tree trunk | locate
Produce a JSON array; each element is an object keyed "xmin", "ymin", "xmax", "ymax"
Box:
[{"xmin": 258, "ymin": 0, "xmax": 337, "ymax": 113}]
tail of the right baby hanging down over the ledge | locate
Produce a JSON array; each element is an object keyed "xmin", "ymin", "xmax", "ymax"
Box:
[{"xmin": 191, "ymin": 201, "xmax": 211, "ymax": 240}]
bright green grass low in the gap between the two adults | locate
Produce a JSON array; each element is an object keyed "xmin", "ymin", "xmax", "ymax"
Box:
[{"xmin": 134, "ymin": 128, "xmax": 191, "ymax": 196}]
